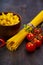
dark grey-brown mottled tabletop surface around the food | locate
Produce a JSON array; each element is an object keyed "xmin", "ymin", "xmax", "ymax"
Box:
[{"xmin": 0, "ymin": 0, "xmax": 43, "ymax": 65}]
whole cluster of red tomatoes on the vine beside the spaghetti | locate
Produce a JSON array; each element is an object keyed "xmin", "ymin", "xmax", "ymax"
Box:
[{"xmin": 26, "ymin": 28, "xmax": 43, "ymax": 52}]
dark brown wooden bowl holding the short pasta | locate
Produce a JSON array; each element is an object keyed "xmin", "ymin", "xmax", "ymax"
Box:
[{"xmin": 0, "ymin": 12, "xmax": 21, "ymax": 37}]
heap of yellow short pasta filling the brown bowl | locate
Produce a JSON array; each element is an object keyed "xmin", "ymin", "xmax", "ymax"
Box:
[{"xmin": 0, "ymin": 12, "xmax": 20, "ymax": 26}]
